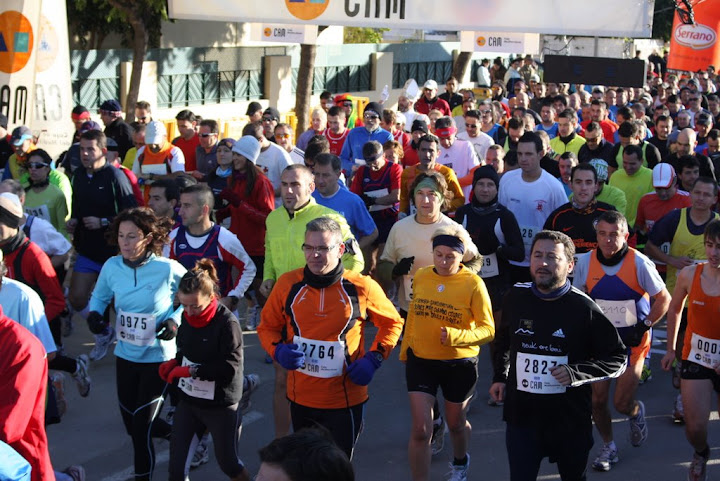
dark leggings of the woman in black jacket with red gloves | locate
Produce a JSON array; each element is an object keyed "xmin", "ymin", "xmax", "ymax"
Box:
[{"xmin": 168, "ymin": 398, "xmax": 245, "ymax": 481}]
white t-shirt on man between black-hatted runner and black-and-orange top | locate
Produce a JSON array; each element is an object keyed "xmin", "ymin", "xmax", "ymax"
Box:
[{"xmin": 498, "ymin": 169, "xmax": 567, "ymax": 267}]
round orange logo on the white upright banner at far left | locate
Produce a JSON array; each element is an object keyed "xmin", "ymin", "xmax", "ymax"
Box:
[{"xmin": 0, "ymin": 10, "xmax": 34, "ymax": 73}]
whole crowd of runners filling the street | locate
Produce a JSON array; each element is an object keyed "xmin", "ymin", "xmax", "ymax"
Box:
[{"xmin": 0, "ymin": 55, "xmax": 720, "ymax": 481}]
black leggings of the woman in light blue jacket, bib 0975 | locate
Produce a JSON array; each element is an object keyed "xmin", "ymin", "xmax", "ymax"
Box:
[{"xmin": 116, "ymin": 357, "xmax": 176, "ymax": 481}]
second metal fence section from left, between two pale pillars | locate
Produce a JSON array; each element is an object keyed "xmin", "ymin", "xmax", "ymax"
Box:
[{"xmin": 158, "ymin": 69, "xmax": 263, "ymax": 108}]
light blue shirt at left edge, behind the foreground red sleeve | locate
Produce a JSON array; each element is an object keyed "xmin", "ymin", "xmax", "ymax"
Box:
[{"xmin": 0, "ymin": 277, "xmax": 57, "ymax": 353}]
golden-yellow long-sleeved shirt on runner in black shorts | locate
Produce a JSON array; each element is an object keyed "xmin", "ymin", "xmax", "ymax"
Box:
[{"xmin": 400, "ymin": 266, "xmax": 495, "ymax": 361}]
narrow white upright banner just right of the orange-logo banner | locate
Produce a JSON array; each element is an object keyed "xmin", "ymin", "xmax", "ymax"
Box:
[{"xmin": 30, "ymin": 0, "xmax": 75, "ymax": 158}]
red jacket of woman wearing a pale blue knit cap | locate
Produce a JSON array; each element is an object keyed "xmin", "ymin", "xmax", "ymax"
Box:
[{"xmin": 224, "ymin": 173, "xmax": 275, "ymax": 256}]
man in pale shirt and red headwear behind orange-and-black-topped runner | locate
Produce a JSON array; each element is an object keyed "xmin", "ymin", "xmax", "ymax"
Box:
[{"xmin": 435, "ymin": 117, "xmax": 480, "ymax": 201}]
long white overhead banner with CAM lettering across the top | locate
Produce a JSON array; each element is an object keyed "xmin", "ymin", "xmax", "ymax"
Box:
[{"xmin": 168, "ymin": 0, "xmax": 654, "ymax": 37}]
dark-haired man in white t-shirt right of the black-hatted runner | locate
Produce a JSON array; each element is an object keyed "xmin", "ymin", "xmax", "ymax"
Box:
[{"xmin": 498, "ymin": 132, "xmax": 567, "ymax": 282}]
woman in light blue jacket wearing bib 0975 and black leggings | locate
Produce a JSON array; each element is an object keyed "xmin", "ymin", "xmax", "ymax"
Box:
[{"xmin": 88, "ymin": 207, "xmax": 186, "ymax": 481}]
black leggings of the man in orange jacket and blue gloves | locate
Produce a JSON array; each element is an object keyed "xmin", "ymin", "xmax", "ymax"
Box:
[{"xmin": 290, "ymin": 401, "xmax": 365, "ymax": 459}]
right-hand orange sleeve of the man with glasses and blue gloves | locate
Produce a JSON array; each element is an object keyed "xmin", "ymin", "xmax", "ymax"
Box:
[{"xmin": 363, "ymin": 277, "xmax": 403, "ymax": 359}]
